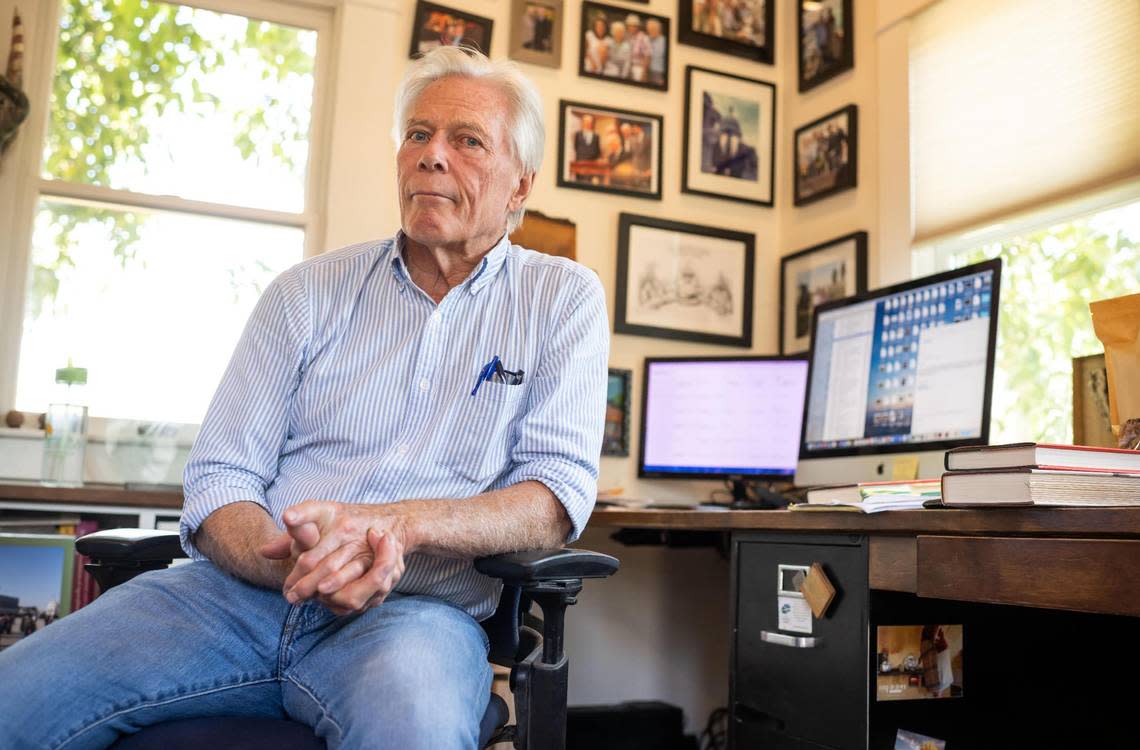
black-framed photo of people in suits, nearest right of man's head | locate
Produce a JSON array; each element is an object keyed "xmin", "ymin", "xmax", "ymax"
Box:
[{"xmin": 557, "ymin": 99, "xmax": 663, "ymax": 201}]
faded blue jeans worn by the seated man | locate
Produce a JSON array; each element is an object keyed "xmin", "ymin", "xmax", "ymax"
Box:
[{"xmin": 0, "ymin": 562, "xmax": 491, "ymax": 750}]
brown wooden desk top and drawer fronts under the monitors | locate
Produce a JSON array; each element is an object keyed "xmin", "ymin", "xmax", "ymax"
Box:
[{"xmin": 589, "ymin": 507, "xmax": 1140, "ymax": 617}]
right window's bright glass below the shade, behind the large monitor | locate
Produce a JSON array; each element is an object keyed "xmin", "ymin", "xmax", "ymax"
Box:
[{"xmin": 919, "ymin": 201, "xmax": 1140, "ymax": 443}]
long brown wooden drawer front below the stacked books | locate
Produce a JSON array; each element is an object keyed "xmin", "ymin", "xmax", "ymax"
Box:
[{"xmin": 918, "ymin": 536, "xmax": 1140, "ymax": 617}]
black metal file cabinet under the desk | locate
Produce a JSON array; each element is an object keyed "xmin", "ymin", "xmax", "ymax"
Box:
[{"xmin": 728, "ymin": 532, "xmax": 870, "ymax": 750}]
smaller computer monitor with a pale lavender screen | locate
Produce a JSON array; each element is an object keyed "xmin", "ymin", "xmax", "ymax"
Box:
[{"xmin": 637, "ymin": 357, "xmax": 807, "ymax": 504}]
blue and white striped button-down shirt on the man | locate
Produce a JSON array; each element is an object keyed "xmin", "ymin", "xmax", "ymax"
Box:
[{"xmin": 181, "ymin": 235, "xmax": 609, "ymax": 619}]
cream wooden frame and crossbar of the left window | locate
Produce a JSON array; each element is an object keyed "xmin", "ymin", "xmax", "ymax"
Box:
[{"xmin": 0, "ymin": 0, "xmax": 340, "ymax": 433}]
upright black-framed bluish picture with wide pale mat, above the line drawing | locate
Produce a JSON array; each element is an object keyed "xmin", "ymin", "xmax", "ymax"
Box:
[{"xmin": 681, "ymin": 65, "xmax": 776, "ymax": 206}]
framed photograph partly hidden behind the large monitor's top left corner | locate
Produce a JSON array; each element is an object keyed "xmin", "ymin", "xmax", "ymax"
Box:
[{"xmin": 780, "ymin": 231, "xmax": 866, "ymax": 354}]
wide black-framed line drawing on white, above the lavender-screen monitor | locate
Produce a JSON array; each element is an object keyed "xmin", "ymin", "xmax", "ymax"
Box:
[{"xmin": 613, "ymin": 213, "xmax": 756, "ymax": 348}]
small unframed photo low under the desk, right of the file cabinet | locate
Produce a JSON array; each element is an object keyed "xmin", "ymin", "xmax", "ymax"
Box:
[{"xmin": 874, "ymin": 625, "xmax": 963, "ymax": 701}]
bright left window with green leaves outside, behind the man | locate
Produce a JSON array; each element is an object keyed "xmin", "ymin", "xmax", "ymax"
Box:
[{"xmin": 16, "ymin": 0, "xmax": 328, "ymax": 423}]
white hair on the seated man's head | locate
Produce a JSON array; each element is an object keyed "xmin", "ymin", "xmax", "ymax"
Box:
[{"xmin": 392, "ymin": 46, "xmax": 545, "ymax": 234}]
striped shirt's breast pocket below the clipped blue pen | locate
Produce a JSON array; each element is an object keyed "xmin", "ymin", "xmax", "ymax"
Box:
[{"xmin": 440, "ymin": 381, "xmax": 528, "ymax": 481}]
